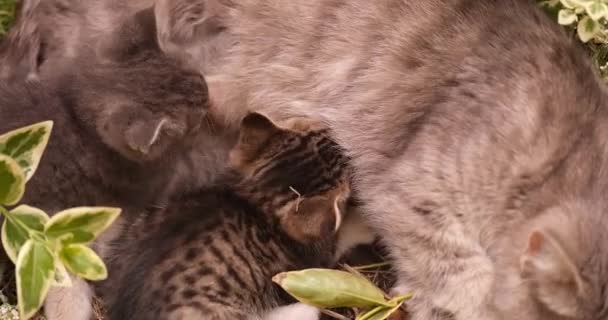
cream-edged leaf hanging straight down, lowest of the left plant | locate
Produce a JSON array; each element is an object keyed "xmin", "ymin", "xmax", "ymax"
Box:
[{"xmin": 15, "ymin": 240, "xmax": 55, "ymax": 319}]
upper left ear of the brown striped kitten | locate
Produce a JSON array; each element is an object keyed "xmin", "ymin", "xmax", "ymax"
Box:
[{"xmin": 230, "ymin": 112, "xmax": 282, "ymax": 166}]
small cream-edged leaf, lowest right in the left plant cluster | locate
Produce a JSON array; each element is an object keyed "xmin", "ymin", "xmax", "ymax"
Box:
[{"xmin": 59, "ymin": 244, "xmax": 108, "ymax": 281}]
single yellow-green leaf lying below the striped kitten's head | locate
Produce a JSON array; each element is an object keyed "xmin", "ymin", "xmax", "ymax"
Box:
[{"xmin": 272, "ymin": 269, "xmax": 393, "ymax": 308}]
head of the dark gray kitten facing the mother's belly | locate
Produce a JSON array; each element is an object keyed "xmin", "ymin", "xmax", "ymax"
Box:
[{"xmin": 61, "ymin": 8, "xmax": 208, "ymax": 162}]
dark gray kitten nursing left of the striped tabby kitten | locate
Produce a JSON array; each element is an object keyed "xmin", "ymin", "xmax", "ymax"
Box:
[{"xmin": 0, "ymin": 2, "xmax": 234, "ymax": 320}]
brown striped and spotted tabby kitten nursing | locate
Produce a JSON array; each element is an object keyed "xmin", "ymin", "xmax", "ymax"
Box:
[{"xmin": 99, "ymin": 113, "xmax": 351, "ymax": 320}]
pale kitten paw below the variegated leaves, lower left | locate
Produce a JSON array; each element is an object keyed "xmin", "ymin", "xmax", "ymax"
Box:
[{"xmin": 44, "ymin": 277, "xmax": 93, "ymax": 320}]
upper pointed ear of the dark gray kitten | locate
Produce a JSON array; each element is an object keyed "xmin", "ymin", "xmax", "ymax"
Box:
[{"xmin": 97, "ymin": 8, "xmax": 158, "ymax": 62}]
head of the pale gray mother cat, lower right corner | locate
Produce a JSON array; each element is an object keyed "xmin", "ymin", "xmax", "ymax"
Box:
[{"xmin": 494, "ymin": 202, "xmax": 608, "ymax": 320}]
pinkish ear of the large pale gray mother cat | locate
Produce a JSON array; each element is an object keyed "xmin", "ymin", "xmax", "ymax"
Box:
[{"xmin": 520, "ymin": 231, "xmax": 582, "ymax": 317}]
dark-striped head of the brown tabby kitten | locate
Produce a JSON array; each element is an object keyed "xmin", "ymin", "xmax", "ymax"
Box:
[{"xmin": 230, "ymin": 113, "xmax": 351, "ymax": 243}]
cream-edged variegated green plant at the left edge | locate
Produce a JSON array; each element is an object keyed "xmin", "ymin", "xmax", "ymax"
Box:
[{"xmin": 0, "ymin": 121, "xmax": 120, "ymax": 320}]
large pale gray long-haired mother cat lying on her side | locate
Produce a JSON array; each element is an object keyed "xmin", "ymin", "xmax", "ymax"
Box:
[{"xmin": 156, "ymin": 0, "xmax": 608, "ymax": 320}]
